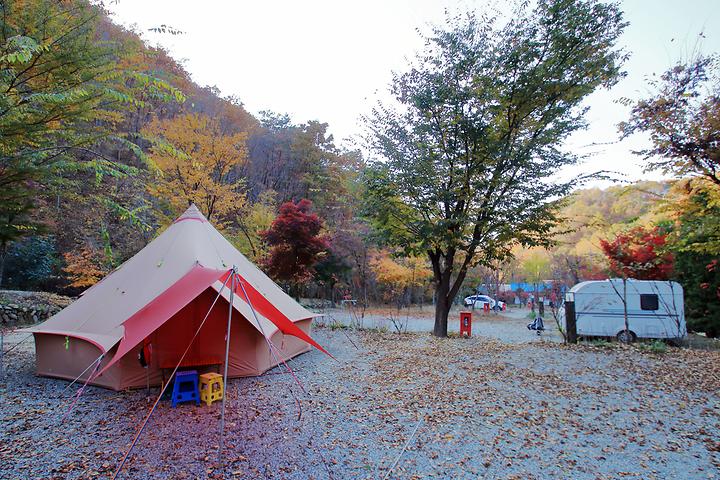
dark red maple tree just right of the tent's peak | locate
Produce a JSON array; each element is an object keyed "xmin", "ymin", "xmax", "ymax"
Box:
[{"xmin": 260, "ymin": 199, "xmax": 330, "ymax": 284}]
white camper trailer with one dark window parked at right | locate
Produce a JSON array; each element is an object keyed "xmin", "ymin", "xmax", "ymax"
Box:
[{"xmin": 566, "ymin": 278, "xmax": 687, "ymax": 341}]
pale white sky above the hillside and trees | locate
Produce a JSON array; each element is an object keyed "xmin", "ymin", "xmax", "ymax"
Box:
[{"xmin": 108, "ymin": 0, "xmax": 720, "ymax": 187}]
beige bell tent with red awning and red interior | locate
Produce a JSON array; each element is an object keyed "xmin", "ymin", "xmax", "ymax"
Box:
[{"xmin": 26, "ymin": 205, "xmax": 327, "ymax": 390}]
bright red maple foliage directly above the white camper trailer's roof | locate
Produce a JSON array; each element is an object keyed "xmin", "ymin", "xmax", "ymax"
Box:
[{"xmin": 600, "ymin": 227, "xmax": 674, "ymax": 280}]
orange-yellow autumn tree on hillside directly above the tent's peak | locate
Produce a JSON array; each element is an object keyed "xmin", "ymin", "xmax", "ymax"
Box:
[{"xmin": 144, "ymin": 114, "xmax": 247, "ymax": 226}]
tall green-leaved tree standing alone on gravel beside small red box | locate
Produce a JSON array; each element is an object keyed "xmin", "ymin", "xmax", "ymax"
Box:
[{"xmin": 367, "ymin": 0, "xmax": 625, "ymax": 336}]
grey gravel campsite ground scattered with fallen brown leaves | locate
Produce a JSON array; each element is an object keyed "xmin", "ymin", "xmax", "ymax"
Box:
[{"xmin": 0, "ymin": 328, "xmax": 720, "ymax": 479}]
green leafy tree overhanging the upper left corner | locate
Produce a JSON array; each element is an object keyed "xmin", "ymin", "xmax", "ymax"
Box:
[{"xmin": 0, "ymin": 0, "xmax": 182, "ymax": 284}]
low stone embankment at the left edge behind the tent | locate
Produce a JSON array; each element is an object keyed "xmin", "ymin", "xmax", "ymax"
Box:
[{"xmin": 0, "ymin": 290, "xmax": 73, "ymax": 328}]
